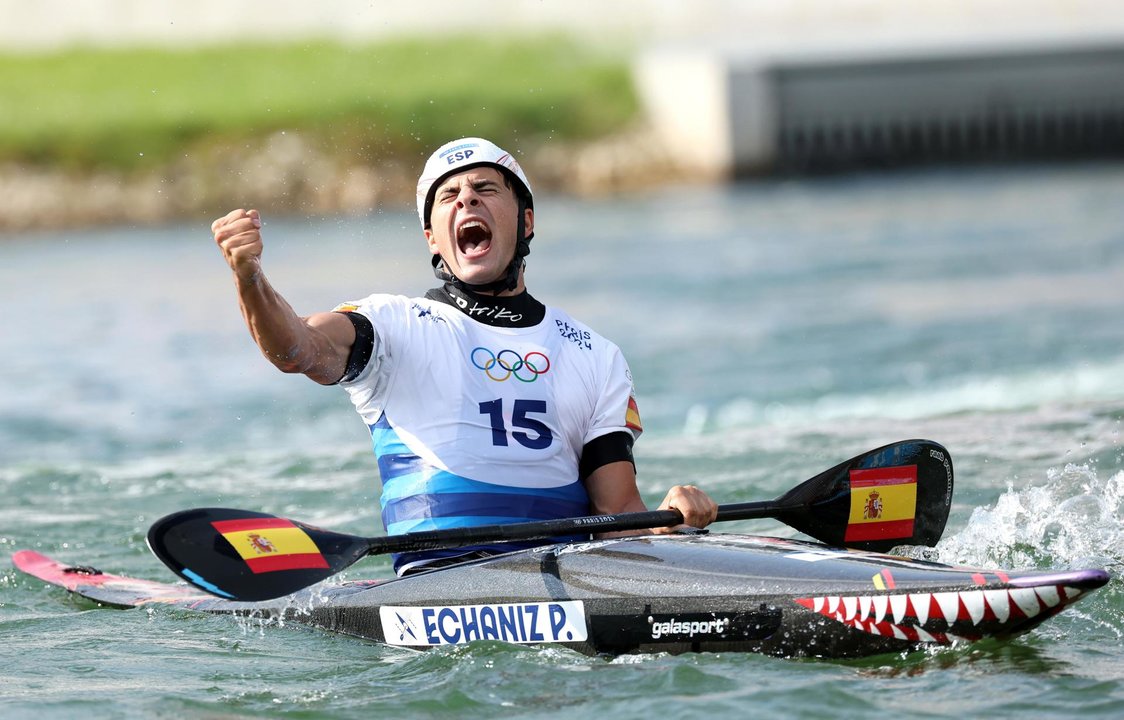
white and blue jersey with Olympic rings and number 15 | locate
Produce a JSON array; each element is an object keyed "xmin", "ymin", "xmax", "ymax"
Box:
[{"xmin": 336, "ymin": 294, "xmax": 641, "ymax": 565}]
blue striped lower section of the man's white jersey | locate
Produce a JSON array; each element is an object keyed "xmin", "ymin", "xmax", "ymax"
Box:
[{"xmin": 371, "ymin": 416, "xmax": 589, "ymax": 568}]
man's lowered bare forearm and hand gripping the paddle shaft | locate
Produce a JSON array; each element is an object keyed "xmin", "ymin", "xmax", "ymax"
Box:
[{"xmin": 586, "ymin": 461, "xmax": 718, "ymax": 537}]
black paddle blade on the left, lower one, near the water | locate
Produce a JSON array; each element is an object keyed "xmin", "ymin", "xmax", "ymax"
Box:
[{"xmin": 142, "ymin": 508, "xmax": 369, "ymax": 601}]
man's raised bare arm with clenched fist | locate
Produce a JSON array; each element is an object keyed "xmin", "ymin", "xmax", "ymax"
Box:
[{"xmin": 211, "ymin": 210, "xmax": 355, "ymax": 385}]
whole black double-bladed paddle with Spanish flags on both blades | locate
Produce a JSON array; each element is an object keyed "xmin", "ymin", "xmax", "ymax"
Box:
[{"xmin": 148, "ymin": 440, "xmax": 952, "ymax": 600}]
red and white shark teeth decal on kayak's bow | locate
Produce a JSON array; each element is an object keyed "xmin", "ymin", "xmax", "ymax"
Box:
[{"xmin": 796, "ymin": 585, "xmax": 1084, "ymax": 645}]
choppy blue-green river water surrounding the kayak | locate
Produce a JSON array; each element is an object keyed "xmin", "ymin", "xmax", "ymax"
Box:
[{"xmin": 0, "ymin": 165, "xmax": 1124, "ymax": 719}]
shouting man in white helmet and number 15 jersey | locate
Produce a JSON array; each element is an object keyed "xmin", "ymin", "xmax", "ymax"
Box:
[{"xmin": 211, "ymin": 138, "xmax": 717, "ymax": 574}]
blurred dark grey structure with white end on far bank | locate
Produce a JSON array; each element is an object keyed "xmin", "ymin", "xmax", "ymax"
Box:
[{"xmin": 637, "ymin": 43, "xmax": 1124, "ymax": 175}]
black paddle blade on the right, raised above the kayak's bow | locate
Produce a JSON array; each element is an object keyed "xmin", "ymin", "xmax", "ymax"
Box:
[{"xmin": 776, "ymin": 440, "xmax": 952, "ymax": 553}]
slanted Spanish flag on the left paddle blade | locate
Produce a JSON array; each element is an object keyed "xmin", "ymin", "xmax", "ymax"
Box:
[{"xmin": 211, "ymin": 518, "xmax": 328, "ymax": 574}]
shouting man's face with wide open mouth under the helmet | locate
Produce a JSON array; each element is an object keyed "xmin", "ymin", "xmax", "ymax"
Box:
[{"xmin": 425, "ymin": 167, "xmax": 535, "ymax": 291}]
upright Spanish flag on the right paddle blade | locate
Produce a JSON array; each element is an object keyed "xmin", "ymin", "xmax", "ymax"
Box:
[{"xmin": 843, "ymin": 465, "xmax": 917, "ymax": 543}]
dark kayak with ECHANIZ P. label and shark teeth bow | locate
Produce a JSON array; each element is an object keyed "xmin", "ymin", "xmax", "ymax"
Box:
[{"xmin": 12, "ymin": 532, "xmax": 1109, "ymax": 658}]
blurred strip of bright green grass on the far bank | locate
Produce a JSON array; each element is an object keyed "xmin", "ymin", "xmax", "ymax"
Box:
[{"xmin": 0, "ymin": 36, "xmax": 637, "ymax": 170}]
